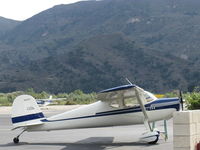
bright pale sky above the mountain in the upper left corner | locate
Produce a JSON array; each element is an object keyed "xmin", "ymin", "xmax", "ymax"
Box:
[{"xmin": 0, "ymin": 0, "xmax": 81, "ymax": 20}]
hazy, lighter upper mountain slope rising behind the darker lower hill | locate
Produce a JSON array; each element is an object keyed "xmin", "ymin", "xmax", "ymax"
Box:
[{"xmin": 1, "ymin": 0, "xmax": 200, "ymax": 61}]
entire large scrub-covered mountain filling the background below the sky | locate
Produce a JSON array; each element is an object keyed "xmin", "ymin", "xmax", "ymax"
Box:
[{"xmin": 0, "ymin": 0, "xmax": 200, "ymax": 93}]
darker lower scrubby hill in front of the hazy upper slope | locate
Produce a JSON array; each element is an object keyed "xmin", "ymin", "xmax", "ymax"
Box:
[{"xmin": 1, "ymin": 34, "xmax": 200, "ymax": 93}]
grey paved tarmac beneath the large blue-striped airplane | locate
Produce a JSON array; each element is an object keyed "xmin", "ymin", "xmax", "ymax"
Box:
[{"xmin": 0, "ymin": 106, "xmax": 173, "ymax": 150}]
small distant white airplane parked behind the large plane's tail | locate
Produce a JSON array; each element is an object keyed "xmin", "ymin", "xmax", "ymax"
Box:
[{"xmin": 36, "ymin": 95, "xmax": 65, "ymax": 107}]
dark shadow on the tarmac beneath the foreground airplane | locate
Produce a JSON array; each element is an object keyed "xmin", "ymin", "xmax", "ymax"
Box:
[{"xmin": 1, "ymin": 137, "xmax": 155, "ymax": 150}]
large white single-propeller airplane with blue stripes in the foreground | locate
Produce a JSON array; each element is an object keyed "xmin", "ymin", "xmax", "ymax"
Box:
[{"xmin": 11, "ymin": 84, "xmax": 180, "ymax": 144}]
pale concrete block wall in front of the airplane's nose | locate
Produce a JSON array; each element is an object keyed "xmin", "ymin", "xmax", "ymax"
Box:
[{"xmin": 173, "ymin": 110, "xmax": 200, "ymax": 150}]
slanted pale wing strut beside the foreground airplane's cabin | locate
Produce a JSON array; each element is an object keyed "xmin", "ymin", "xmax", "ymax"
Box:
[{"xmin": 134, "ymin": 87, "xmax": 153, "ymax": 131}]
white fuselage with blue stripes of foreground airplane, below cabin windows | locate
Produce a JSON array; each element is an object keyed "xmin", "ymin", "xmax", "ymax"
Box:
[{"xmin": 26, "ymin": 98, "xmax": 179, "ymax": 131}]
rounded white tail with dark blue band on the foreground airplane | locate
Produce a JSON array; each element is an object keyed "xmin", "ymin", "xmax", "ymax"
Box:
[{"xmin": 11, "ymin": 95, "xmax": 45, "ymax": 129}]
